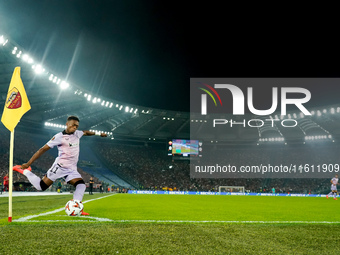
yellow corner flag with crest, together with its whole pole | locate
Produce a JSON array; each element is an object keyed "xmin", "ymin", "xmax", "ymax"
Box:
[{"xmin": 1, "ymin": 67, "xmax": 31, "ymax": 222}]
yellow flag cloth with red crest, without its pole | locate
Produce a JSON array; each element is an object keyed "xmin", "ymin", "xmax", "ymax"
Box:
[{"xmin": 1, "ymin": 67, "xmax": 31, "ymax": 132}]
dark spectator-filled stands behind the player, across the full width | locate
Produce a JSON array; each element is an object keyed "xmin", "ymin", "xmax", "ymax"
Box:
[{"xmin": 0, "ymin": 128, "xmax": 340, "ymax": 193}]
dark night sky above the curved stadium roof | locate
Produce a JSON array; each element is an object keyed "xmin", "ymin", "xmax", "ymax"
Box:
[{"xmin": 0, "ymin": 0, "xmax": 340, "ymax": 111}]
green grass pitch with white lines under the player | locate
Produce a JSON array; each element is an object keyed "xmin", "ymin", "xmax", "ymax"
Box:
[{"xmin": 0, "ymin": 194, "xmax": 340, "ymax": 255}]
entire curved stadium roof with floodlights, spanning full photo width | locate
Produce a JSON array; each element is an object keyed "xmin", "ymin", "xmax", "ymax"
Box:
[{"xmin": 0, "ymin": 35, "xmax": 340, "ymax": 144}]
